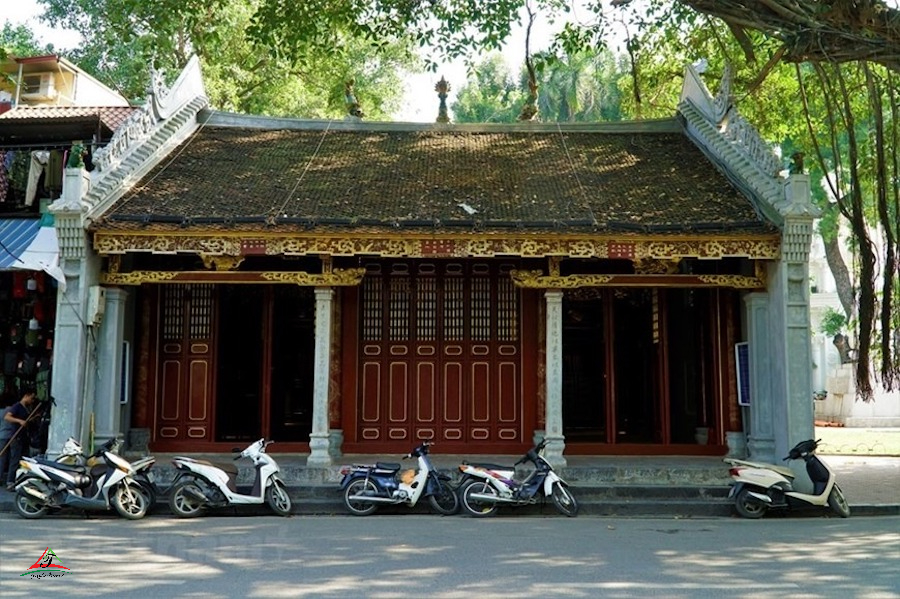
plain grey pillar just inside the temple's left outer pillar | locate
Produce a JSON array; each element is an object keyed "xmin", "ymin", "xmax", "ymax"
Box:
[{"xmin": 94, "ymin": 288, "xmax": 128, "ymax": 446}]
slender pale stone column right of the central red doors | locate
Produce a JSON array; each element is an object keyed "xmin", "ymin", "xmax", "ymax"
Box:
[{"xmin": 544, "ymin": 289, "xmax": 566, "ymax": 468}]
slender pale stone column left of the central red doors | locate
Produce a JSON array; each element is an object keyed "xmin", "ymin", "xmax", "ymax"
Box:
[{"xmin": 306, "ymin": 287, "xmax": 334, "ymax": 466}]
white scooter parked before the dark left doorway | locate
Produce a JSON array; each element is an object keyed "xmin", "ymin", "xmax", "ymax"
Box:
[{"xmin": 169, "ymin": 439, "xmax": 291, "ymax": 518}]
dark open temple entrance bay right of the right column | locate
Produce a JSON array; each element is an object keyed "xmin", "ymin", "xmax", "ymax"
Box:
[{"xmin": 562, "ymin": 288, "xmax": 734, "ymax": 453}]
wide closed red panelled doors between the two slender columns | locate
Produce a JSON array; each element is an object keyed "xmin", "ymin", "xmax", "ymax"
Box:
[{"xmin": 356, "ymin": 261, "xmax": 523, "ymax": 449}]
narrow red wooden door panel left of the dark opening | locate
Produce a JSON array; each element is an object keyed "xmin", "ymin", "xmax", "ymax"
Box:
[{"xmin": 156, "ymin": 285, "xmax": 215, "ymax": 442}]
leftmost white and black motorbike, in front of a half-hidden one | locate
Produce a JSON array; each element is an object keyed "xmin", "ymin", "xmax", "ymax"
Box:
[{"xmin": 15, "ymin": 450, "xmax": 149, "ymax": 520}]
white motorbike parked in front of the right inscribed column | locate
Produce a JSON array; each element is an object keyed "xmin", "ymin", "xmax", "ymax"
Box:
[{"xmin": 459, "ymin": 439, "xmax": 578, "ymax": 518}]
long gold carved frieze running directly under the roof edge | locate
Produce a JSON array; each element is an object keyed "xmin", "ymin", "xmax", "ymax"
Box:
[{"xmin": 94, "ymin": 230, "xmax": 781, "ymax": 260}]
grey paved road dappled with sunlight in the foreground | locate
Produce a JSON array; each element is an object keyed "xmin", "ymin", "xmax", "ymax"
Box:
[{"xmin": 0, "ymin": 514, "xmax": 900, "ymax": 599}]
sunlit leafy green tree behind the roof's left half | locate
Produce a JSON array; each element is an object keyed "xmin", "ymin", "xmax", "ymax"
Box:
[{"xmin": 39, "ymin": 0, "xmax": 416, "ymax": 118}]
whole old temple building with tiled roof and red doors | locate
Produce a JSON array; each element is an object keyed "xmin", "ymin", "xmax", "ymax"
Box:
[{"xmin": 44, "ymin": 60, "xmax": 815, "ymax": 465}]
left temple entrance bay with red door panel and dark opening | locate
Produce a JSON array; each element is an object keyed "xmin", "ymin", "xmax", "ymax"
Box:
[{"xmin": 157, "ymin": 285, "xmax": 315, "ymax": 449}]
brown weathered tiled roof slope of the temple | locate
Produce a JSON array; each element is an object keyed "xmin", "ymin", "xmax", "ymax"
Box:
[{"xmin": 92, "ymin": 118, "xmax": 774, "ymax": 233}]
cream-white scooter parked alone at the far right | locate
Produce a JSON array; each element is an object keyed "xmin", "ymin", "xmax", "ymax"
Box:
[{"xmin": 725, "ymin": 439, "xmax": 850, "ymax": 518}]
